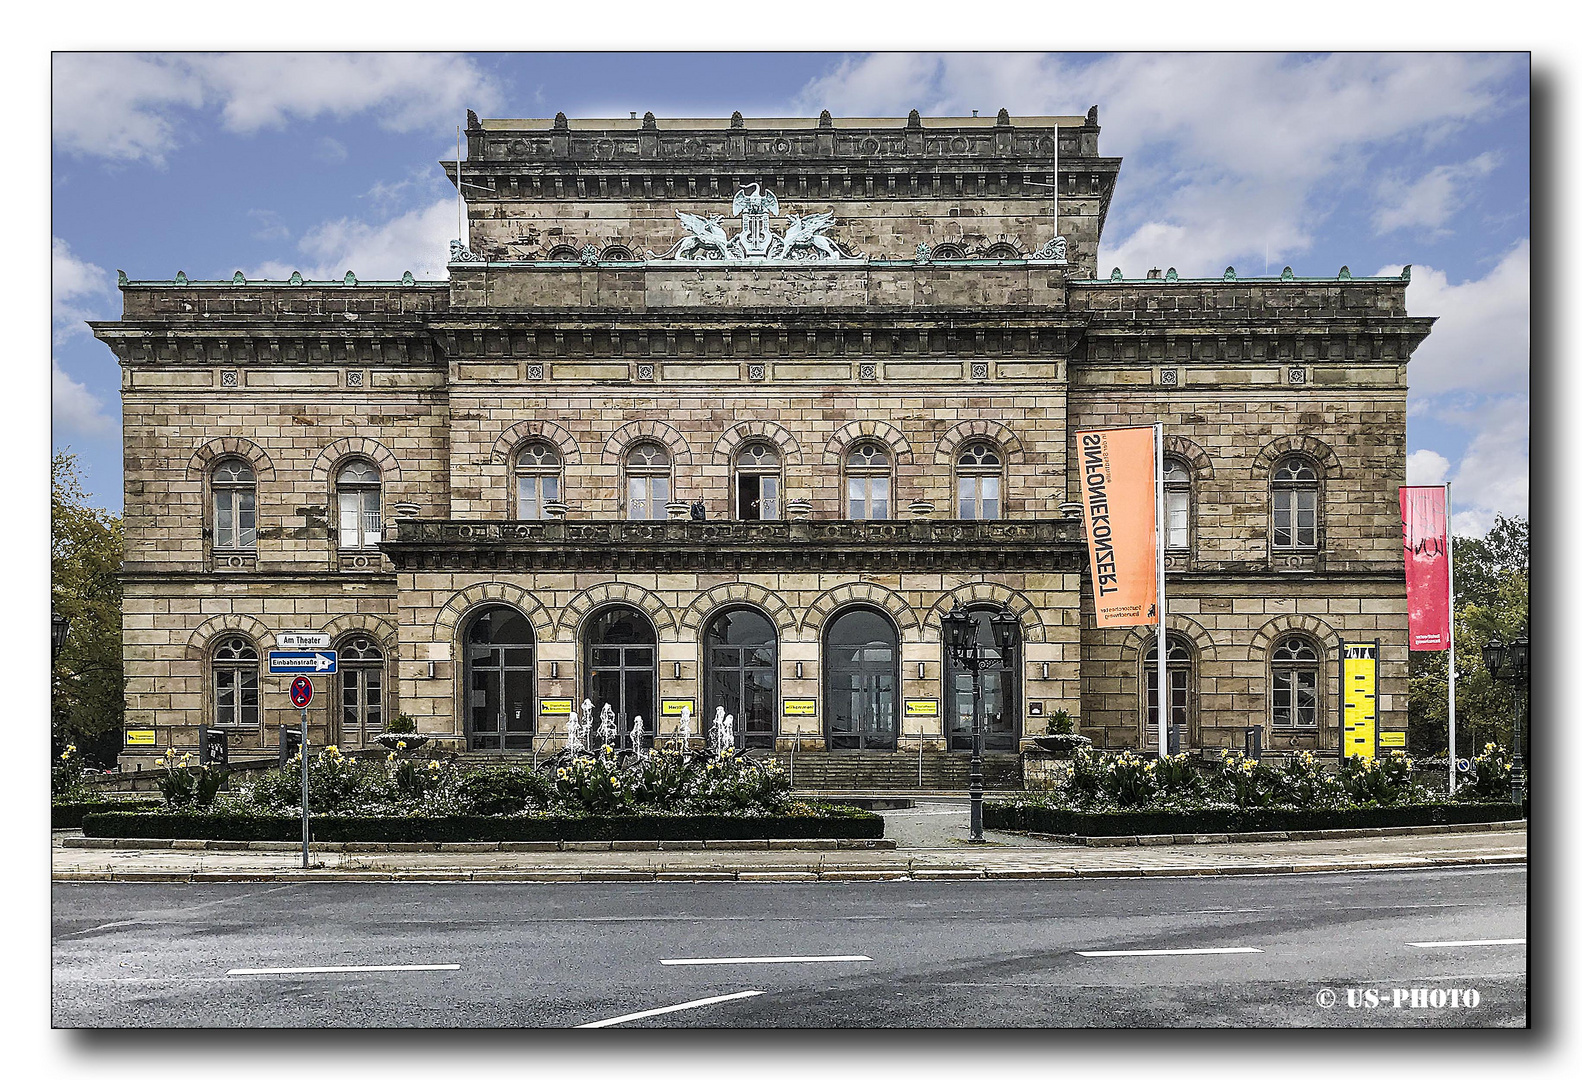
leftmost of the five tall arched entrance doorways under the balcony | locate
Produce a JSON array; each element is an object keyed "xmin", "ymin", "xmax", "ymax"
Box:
[{"xmin": 465, "ymin": 604, "xmax": 533, "ymax": 751}]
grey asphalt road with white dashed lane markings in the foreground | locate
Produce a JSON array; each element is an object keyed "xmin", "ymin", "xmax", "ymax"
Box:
[{"xmin": 52, "ymin": 867, "xmax": 1527, "ymax": 1028}]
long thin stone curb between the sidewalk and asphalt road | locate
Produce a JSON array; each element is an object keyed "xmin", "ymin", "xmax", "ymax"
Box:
[{"xmin": 52, "ymin": 855, "xmax": 1527, "ymax": 884}]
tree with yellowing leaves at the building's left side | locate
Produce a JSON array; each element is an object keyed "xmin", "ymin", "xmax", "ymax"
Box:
[{"xmin": 49, "ymin": 451, "xmax": 125, "ymax": 767}]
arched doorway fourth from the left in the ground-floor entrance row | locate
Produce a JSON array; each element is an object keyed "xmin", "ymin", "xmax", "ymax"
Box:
[{"xmin": 824, "ymin": 607, "xmax": 900, "ymax": 750}]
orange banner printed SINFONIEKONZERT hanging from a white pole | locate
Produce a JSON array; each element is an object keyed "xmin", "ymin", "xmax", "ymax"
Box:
[{"xmin": 1077, "ymin": 427, "xmax": 1158, "ymax": 626}]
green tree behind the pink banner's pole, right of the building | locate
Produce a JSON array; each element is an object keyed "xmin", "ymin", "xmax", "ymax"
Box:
[{"xmin": 1408, "ymin": 515, "xmax": 1528, "ymax": 757}]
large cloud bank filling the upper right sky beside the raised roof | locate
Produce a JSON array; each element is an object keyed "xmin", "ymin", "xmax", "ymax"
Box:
[{"xmin": 797, "ymin": 52, "xmax": 1525, "ymax": 275}]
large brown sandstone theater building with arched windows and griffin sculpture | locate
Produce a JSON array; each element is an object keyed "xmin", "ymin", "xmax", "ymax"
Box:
[{"xmin": 93, "ymin": 109, "xmax": 1430, "ymax": 783}]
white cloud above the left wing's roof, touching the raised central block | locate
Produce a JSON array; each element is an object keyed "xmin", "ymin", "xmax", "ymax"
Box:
[{"xmin": 247, "ymin": 199, "xmax": 456, "ymax": 280}]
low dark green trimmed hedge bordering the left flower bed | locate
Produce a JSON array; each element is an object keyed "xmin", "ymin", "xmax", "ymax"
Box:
[{"xmin": 82, "ymin": 805, "xmax": 884, "ymax": 843}]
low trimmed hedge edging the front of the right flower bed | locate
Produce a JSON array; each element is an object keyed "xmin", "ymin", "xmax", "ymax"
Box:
[{"xmin": 984, "ymin": 802, "xmax": 1522, "ymax": 836}]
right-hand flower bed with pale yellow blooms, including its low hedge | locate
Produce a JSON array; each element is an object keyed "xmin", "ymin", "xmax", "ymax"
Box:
[{"xmin": 984, "ymin": 748, "xmax": 1522, "ymax": 836}]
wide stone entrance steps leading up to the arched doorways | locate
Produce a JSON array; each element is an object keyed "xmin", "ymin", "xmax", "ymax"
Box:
[{"xmin": 768, "ymin": 750, "xmax": 1022, "ymax": 794}]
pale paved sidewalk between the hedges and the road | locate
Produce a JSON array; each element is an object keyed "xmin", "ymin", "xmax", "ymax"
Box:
[{"xmin": 51, "ymin": 800, "xmax": 1527, "ymax": 881}]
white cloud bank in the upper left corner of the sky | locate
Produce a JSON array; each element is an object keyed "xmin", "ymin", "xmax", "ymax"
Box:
[{"xmin": 52, "ymin": 52, "xmax": 503, "ymax": 164}]
